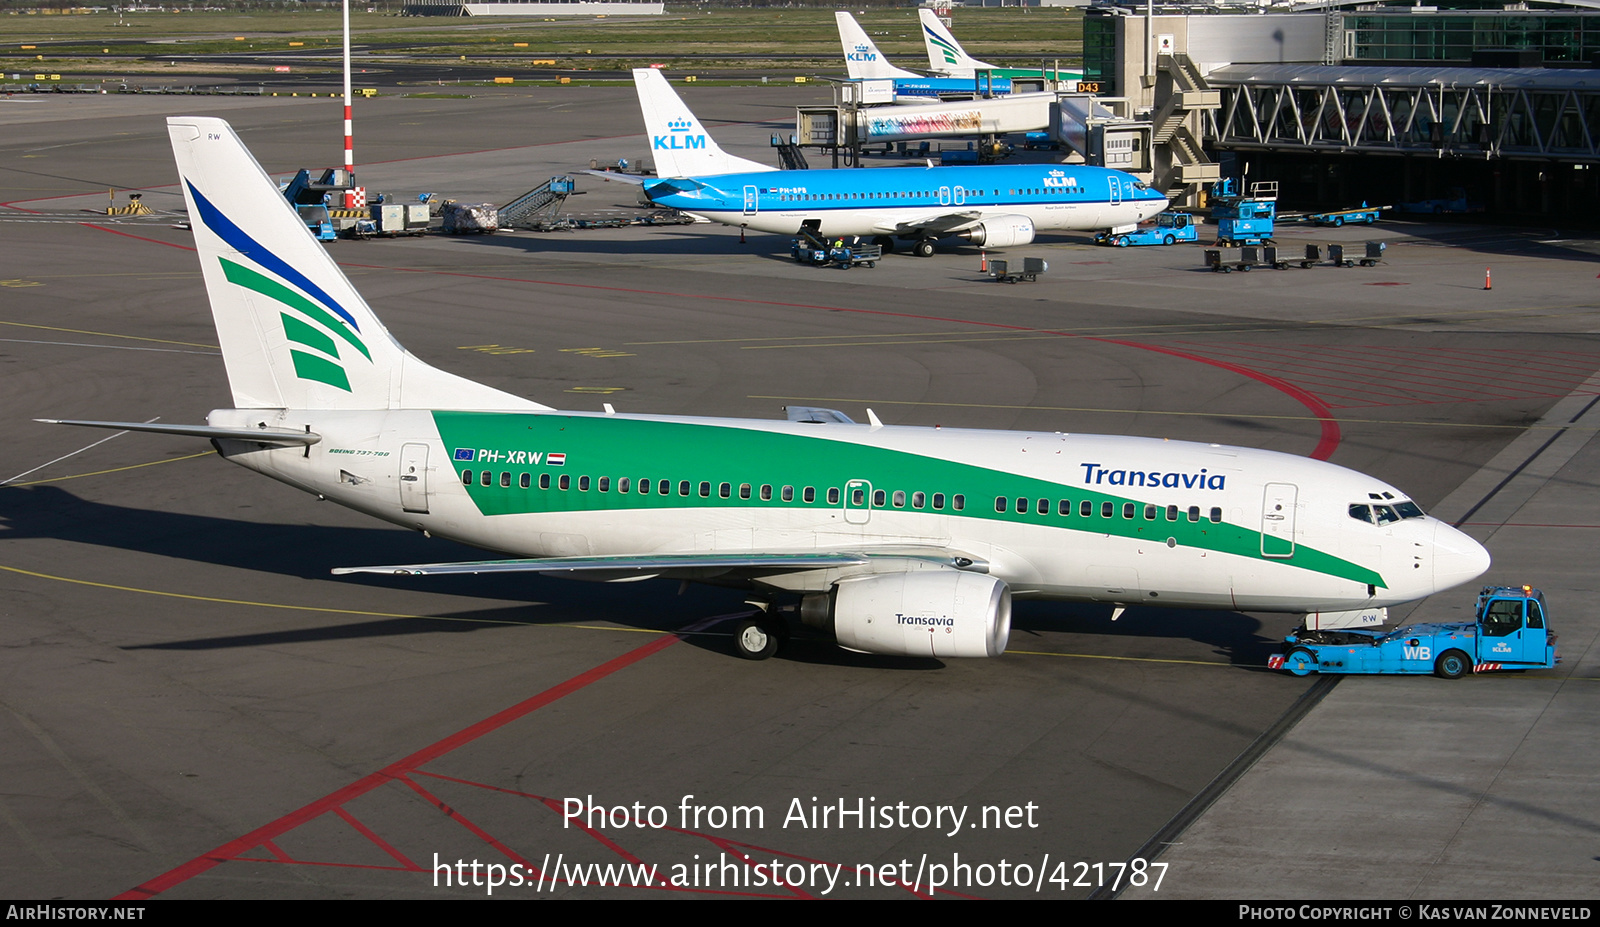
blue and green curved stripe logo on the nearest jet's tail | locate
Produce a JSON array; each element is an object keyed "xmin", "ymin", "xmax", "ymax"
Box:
[{"xmin": 189, "ymin": 184, "xmax": 373, "ymax": 392}]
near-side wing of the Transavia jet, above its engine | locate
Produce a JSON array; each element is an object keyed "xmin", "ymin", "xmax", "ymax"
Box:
[{"xmin": 333, "ymin": 548, "xmax": 989, "ymax": 580}]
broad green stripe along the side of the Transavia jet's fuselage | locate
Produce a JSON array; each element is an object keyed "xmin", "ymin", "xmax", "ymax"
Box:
[{"xmin": 434, "ymin": 411, "xmax": 1387, "ymax": 588}]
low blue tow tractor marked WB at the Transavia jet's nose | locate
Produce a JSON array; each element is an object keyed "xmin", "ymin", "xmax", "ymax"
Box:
[{"xmin": 1267, "ymin": 586, "xmax": 1562, "ymax": 679}]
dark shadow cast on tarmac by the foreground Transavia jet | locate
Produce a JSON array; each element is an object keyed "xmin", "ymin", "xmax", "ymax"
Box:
[{"xmin": 0, "ymin": 487, "xmax": 1275, "ymax": 669}]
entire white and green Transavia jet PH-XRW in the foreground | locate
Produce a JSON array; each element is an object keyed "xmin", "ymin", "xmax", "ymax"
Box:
[{"xmin": 40, "ymin": 117, "xmax": 1490, "ymax": 658}]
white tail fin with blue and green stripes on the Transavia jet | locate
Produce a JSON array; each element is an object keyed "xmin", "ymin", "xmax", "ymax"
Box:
[{"xmin": 166, "ymin": 117, "xmax": 549, "ymax": 410}]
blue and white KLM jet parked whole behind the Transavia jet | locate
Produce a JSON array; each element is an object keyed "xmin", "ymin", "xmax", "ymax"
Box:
[{"xmin": 617, "ymin": 67, "xmax": 1166, "ymax": 256}]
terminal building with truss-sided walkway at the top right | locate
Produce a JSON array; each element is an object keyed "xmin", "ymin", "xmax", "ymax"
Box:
[{"xmin": 1082, "ymin": 0, "xmax": 1600, "ymax": 221}]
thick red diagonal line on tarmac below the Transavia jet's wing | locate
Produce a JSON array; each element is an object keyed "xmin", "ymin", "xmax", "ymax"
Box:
[{"xmin": 117, "ymin": 634, "xmax": 682, "ymax": 901}]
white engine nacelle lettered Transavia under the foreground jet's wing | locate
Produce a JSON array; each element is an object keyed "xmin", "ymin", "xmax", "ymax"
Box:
[{"xmin": 800, "ymin": 570, "xmax": 1011, "ymax": 656}]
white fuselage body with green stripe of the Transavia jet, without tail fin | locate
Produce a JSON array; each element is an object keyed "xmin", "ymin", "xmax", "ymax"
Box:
[{"xmin": 211, "ymin": 410, "xmax": 1488, "ymax": 612}]
